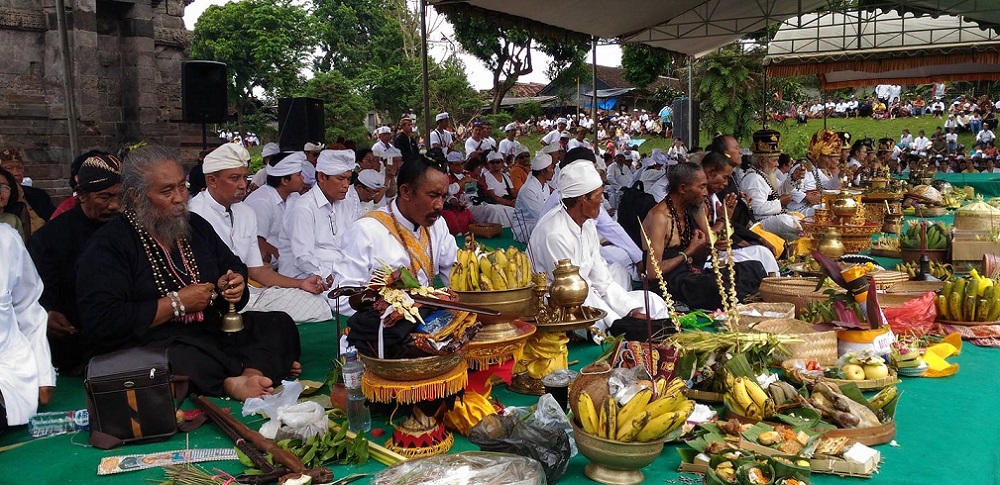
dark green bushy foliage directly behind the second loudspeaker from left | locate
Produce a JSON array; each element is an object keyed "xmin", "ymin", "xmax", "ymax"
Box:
[{"xmin": 296, "ymin": 71, "xmax": 373, "ymax": 141}]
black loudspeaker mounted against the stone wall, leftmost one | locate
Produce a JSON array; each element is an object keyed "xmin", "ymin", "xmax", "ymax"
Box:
[{"xmin": 181, "ymin": 61, "xmax": 229, "ymax": 123}]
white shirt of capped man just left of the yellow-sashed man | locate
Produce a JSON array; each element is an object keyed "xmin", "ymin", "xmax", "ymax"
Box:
[{"xmin": 278, "ymin": 185, "xmax": 354, "ymax": 278}]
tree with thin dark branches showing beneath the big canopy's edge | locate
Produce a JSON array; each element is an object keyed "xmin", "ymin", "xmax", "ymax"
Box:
[{"xmin": 436, "ymin": 7, "xmax": 590, "ymax": 113}]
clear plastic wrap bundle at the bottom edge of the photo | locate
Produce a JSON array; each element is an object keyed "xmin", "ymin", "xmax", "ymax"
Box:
[{"xmin": 371, "ymin": 451, "xmax": 546, "ymax": 485}]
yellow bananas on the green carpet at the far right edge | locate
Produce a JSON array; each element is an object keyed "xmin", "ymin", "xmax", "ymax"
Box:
[{"xmin": 934, "ymin": 270, "xmax": 1000, "ymax": 322}]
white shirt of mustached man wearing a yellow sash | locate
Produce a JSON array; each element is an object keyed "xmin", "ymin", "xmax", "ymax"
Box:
[{"xmin": 331, "ymin": 201, "xmax": 458, "ymax": 315}]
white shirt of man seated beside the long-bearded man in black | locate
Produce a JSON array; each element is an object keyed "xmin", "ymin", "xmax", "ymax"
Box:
[{"xmin": 188, "ymin": 190, "xmax": 264, "ymax": 268}]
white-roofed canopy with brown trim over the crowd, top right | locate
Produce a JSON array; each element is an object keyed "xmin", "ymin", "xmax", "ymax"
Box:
[{"xmin": 765, "ymin": 10, "xmax": 1000, "ymax": 89}]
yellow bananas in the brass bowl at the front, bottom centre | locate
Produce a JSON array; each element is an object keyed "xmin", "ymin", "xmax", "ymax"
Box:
[{"xmin": 579, "ymin": 378, "xmax": 694, "ymax": 443}]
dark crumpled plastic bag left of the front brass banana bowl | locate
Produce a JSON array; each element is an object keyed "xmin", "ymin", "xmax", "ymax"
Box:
[{"xmin": 469, "ymin": 412, "xmax": 570, "ymax": 483}]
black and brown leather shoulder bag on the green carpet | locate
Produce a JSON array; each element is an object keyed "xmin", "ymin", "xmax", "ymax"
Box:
[{"xmin": 83, "ymin": 347, "xmax": 188, "ymax": 450}]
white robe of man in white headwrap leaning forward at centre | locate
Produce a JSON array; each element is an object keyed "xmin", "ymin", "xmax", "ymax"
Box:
[{"xmin": 528, "ymin": 208, "xmax": 666, "ymax": 330}]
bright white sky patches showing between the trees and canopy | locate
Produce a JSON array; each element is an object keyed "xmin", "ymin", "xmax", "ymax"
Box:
[{"xmin": 184, "ymin": 0, "xmax": 621, "ymax": 89}]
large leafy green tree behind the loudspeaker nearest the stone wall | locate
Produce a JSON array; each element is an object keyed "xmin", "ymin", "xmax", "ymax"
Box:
[{"xmin": 191, "ymin": 0, "xmax": 316, "ymax": 131}]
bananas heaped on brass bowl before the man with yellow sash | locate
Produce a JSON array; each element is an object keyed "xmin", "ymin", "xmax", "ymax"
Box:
[{"xmin": 451, "ymin": 246, "xmax": 532, "ymax": 291}]
